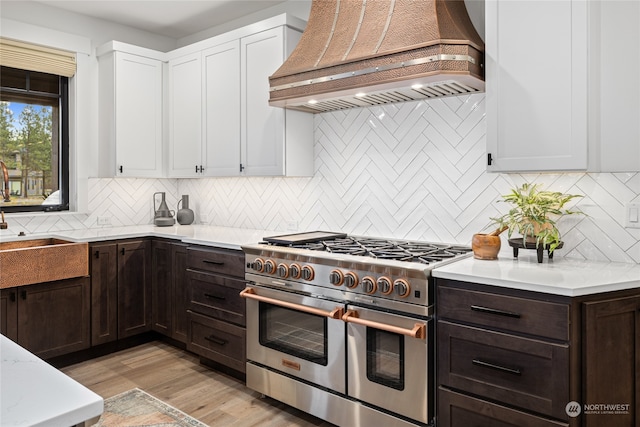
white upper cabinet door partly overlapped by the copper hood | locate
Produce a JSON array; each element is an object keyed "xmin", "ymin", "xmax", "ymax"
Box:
[{"xmin": 240, "ymin": 27, "xmax": 285, "ymax": 175}]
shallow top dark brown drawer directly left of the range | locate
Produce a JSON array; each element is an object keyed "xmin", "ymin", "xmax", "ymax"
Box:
[{"xmin": 187, "ymin": 247, "xmax": 244, "ymax": 277}]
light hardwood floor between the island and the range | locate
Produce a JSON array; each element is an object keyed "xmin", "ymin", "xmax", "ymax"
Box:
[{"xmin": 62, "ymin": 341, "xmax": 332, "ymax": 427}]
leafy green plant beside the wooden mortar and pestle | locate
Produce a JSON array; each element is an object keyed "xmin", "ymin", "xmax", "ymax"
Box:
[{"xmin": 491, "ymin": 183, "xmax": 582, "ymax": 254}]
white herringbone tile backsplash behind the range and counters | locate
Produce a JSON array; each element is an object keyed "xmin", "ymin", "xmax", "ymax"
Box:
[{"xmin": 6, "ymin": 94, "xmax": 640, "ymax": 263}]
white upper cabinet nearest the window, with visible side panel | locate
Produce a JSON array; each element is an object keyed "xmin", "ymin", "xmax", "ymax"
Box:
[{"xmin": 98, "ymin": 46, "xmax": 163, "ymax": 178}]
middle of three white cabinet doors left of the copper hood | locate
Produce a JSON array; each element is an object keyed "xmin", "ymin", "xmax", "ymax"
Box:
[{"xmin": 202, "ymin": 40, "xmax": 240, "ymax": 176}]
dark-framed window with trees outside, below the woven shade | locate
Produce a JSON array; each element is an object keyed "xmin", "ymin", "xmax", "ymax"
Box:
[{"xmin": 0, "ymin": 66, "xmax": 69, "ymax": 212}]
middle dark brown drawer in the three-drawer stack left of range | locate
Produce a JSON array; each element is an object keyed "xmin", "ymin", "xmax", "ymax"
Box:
[{"xmin": 188, "ymin": 271, "xmax": 246, "ymax": 326}]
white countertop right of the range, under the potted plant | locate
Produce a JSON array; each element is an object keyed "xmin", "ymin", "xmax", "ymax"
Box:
[{"xmin": 433, "ymin": 251, "xmax": 640, "ymax": 297}]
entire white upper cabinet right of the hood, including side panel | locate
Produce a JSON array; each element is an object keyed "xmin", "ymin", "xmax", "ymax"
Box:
[{"xmin": 485, "ymin": 0, "xmax": 640, "ymax": 172}]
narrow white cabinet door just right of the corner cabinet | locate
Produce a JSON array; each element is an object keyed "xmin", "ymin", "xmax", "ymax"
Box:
[{"xmin": 168, "ymin": 52, "xmax": 204, "ymax": 177}]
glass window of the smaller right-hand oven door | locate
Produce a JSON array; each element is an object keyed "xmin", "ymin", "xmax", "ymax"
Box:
[{"xmin": 367, "ymin": 328, "xmax": 405, "ymax": 390}]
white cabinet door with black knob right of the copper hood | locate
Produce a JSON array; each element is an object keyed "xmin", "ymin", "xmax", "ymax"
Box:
[{"xmin": 485, "ymin": 0, "xmax": 588, "ymax": 171}]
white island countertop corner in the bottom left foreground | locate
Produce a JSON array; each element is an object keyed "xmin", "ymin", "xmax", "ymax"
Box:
[{"xmin": 0, "ymin": 335, "xmax": 104, "ymax": 427}]
